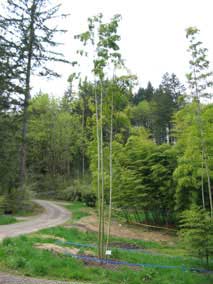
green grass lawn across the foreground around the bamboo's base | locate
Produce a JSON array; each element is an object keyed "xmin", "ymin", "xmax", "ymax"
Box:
[{"xmin": 0, "ymin": 203, "xmax": 213, "ymax": 284}]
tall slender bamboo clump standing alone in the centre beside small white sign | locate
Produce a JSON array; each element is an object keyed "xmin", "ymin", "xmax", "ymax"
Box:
[{"xmin": 76, "ymin": 14, "xmax": 121, "ymax": 258}]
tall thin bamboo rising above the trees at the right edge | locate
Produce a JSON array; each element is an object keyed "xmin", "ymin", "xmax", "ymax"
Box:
[{"xmin": 186, "ymin": 27, "xmax": 213, "ymax": 217}]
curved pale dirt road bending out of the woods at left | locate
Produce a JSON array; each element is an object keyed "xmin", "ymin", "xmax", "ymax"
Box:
[{"xmin": 0, "ymin": 200, "xmax": 70, "ymax": 240}]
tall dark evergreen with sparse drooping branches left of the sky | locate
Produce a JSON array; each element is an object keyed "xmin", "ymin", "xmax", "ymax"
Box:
[{"xmin": 0, "ymin": 0, "xmax": 66, "ymax": 200}]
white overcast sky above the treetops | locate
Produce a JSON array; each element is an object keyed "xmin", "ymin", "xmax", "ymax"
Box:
[{"xmin": 33, "ymin": 0, "xmax": 213, "ymax": 96}]
